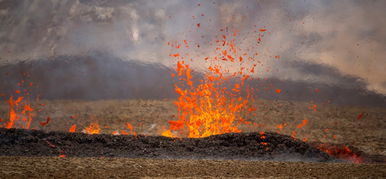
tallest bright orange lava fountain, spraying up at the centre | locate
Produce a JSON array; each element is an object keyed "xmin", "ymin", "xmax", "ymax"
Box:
[{"xmin": 162, "ymin": 30, "xmax": 256, "ymax": 138}]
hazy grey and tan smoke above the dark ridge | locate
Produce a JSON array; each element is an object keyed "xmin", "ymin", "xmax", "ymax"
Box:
[{"xmin": 0, "ymin": 0, "xmax": 386, "ymax": 95}]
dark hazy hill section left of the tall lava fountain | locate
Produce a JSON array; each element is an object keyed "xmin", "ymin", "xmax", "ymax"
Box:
[{"xmin": 0, "ymin": 54, "xmax": 175, "ymax": 100}]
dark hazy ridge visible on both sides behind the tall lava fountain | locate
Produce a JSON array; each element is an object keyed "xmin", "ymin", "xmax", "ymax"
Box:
[{"xmin": 0, "ymin": 53, "xmax": 386, "ymax": 107}]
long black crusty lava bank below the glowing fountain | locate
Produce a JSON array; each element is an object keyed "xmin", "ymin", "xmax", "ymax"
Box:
[{"xmin": 0, "ymin": 128, "xmax": 346, "ymax": 162}]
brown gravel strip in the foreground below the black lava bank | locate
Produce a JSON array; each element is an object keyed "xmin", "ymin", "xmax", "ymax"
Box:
[{"xmin": 0, "ymin": 156, "xmax": 386, "ymax": 178}]
